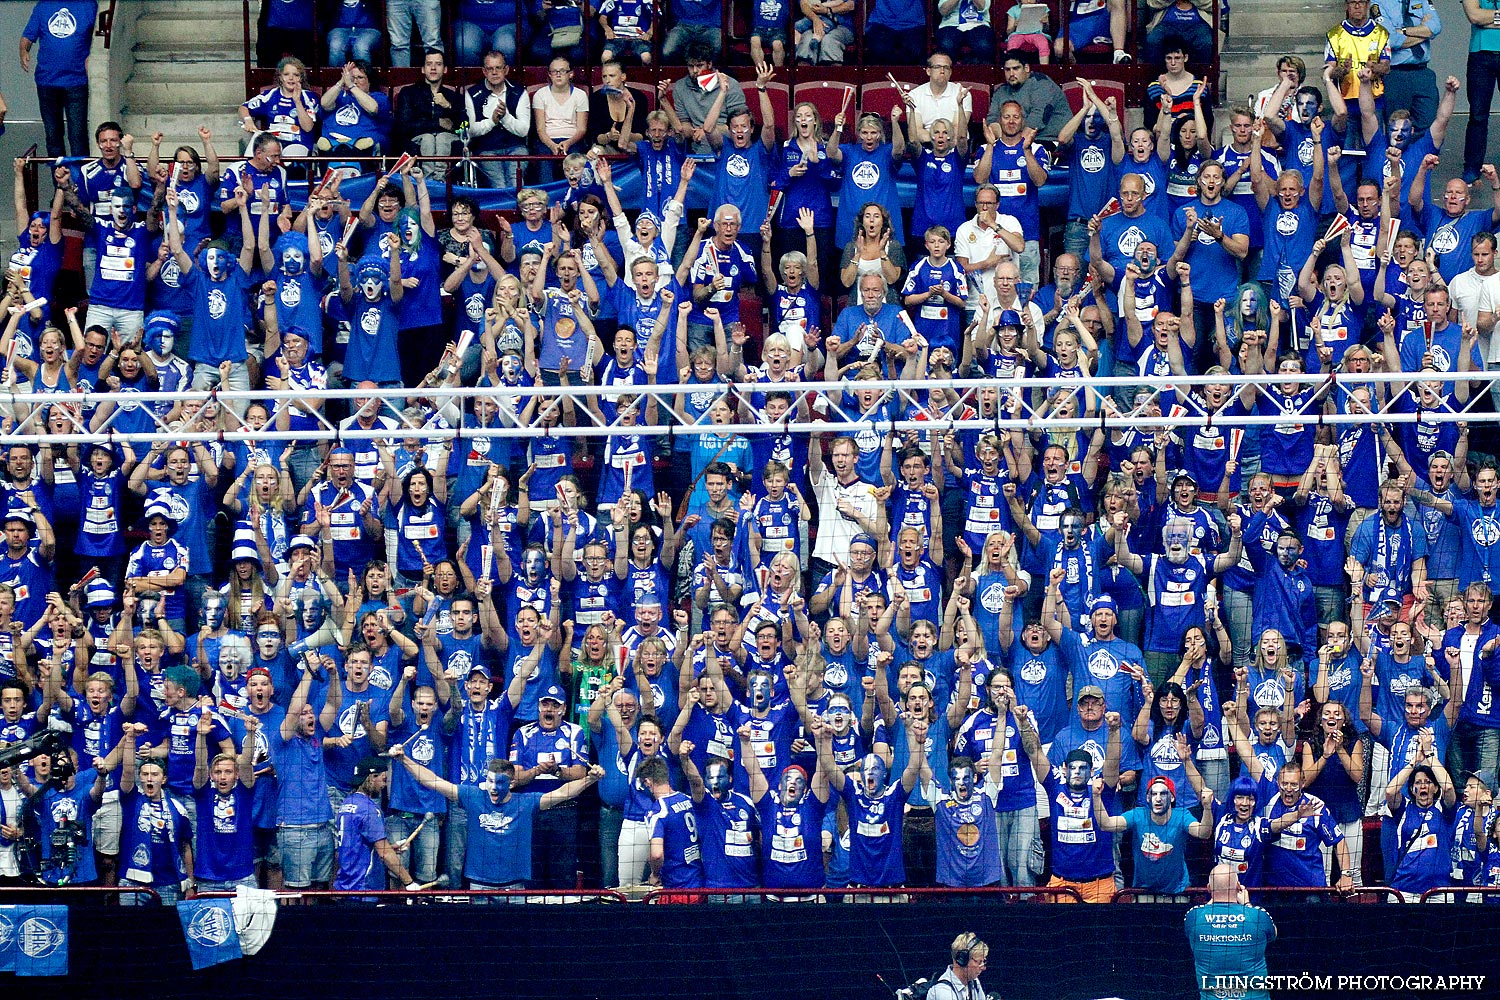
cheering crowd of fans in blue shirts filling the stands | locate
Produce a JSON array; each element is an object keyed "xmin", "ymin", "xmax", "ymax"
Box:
[{"xmin": 0, "ymin": 0, "xmax": 1500, "ymax": 903}]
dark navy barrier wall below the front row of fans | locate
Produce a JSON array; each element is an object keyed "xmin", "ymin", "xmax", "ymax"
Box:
[{"xmin": 24, "ymin": 901, "xmax": 1500, "ymax": 1000}]
